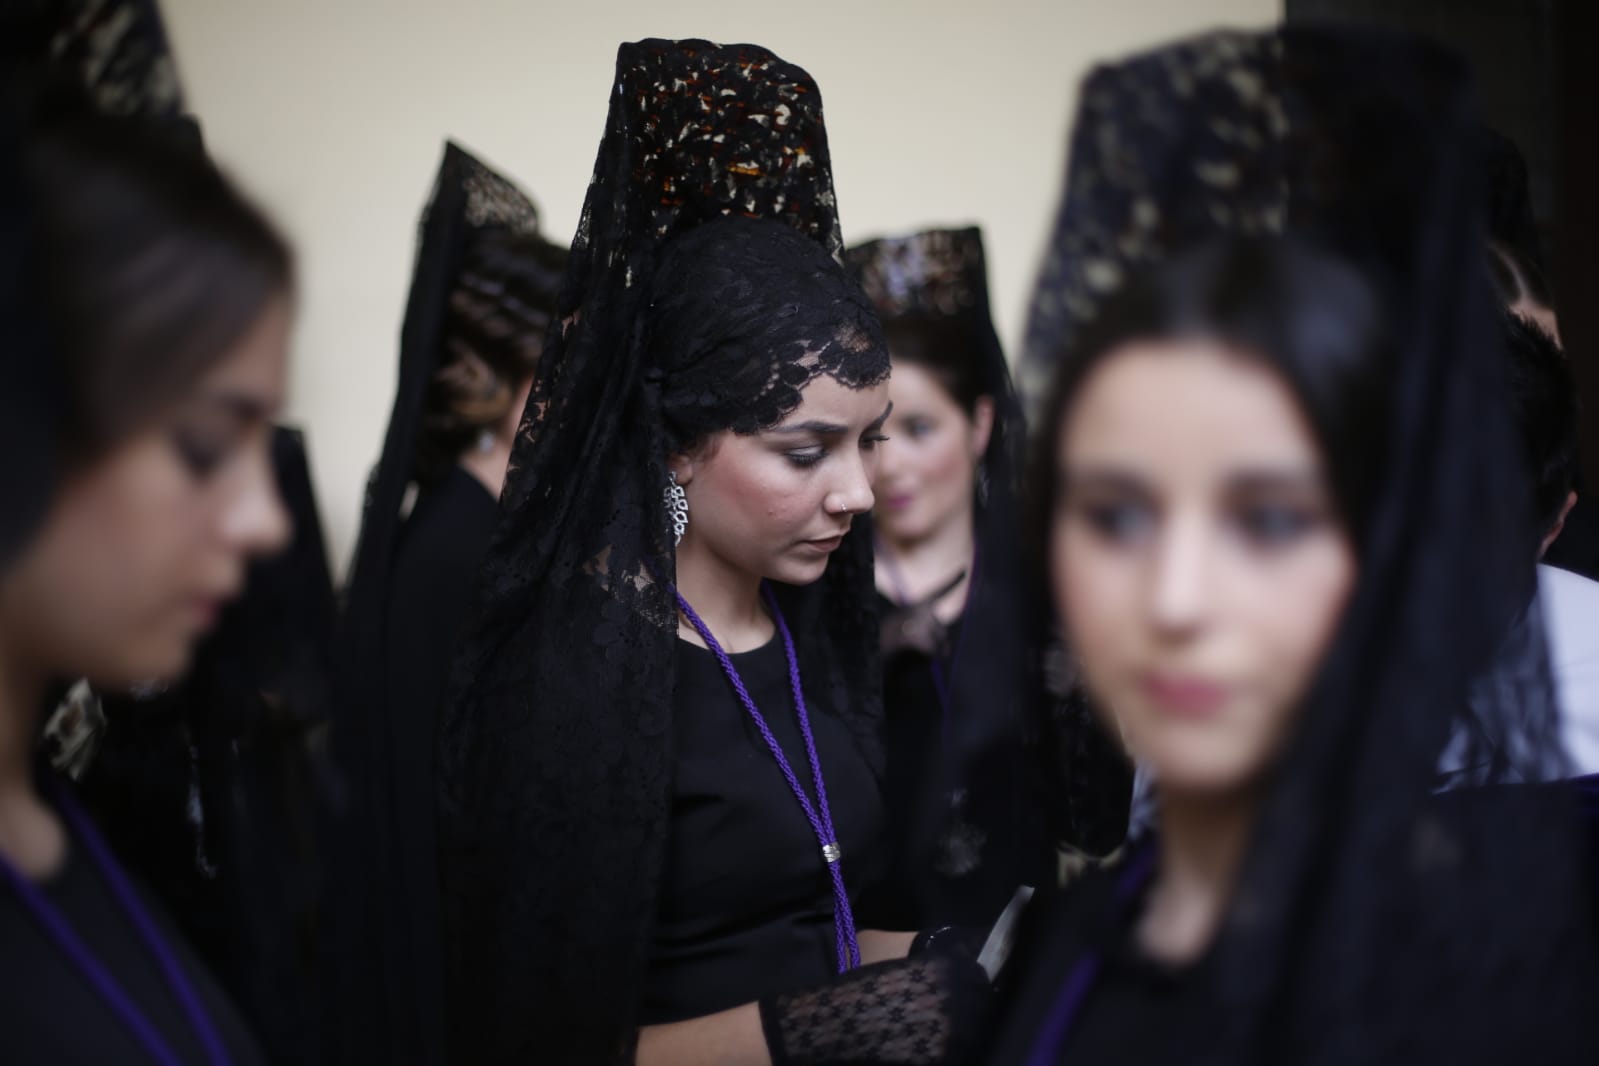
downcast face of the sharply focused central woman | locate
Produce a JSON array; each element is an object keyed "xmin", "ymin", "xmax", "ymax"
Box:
[{"xmin": 670, "ymin": 376, "xmax": 889, "ymax": 585}]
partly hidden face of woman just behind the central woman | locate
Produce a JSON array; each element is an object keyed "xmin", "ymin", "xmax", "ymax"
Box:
[{"xmin": 873, "ymin": 360, "xmax": 993, "ymax": 543}]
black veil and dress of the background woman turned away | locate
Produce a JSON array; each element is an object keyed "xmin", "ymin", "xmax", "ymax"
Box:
[{"xmin": 329, "ymin": 144, "xmax": 539, "ymax": 1066}]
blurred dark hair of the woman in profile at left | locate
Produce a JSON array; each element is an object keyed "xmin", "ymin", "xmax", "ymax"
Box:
[{"xmin": 24, "ymin": 115, "xmax": 293, "ymax": 460}]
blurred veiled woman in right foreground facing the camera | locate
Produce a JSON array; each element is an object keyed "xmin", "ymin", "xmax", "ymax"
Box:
[{"xmin": 993, "ymin": 29, "xmax": 1599, "ymax": 1063}]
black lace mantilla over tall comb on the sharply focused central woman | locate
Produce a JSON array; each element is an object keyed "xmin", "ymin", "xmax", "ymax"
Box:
[{"xmin": 438, "ymin": 40, "xmax": 887, "ymax": 1063}]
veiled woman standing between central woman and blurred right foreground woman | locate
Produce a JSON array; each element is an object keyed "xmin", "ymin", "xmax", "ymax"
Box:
[{"xmin": 847, "ymin": 229, "xmax": 1054, "ymax": 932}]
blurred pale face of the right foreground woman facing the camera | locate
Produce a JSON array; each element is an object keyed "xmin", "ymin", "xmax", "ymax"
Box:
[{"xmin": 1051, "ymin": 340, "xmax": 1356, "ymax": 793}]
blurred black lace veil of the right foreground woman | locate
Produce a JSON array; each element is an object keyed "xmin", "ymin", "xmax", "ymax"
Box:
[{"xmin": 1027, "ymin": 27, "xmax": 1594, "ymax": 1063}]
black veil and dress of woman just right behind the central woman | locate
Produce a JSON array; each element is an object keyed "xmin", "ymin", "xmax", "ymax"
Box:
[{"xmin": 847, "ymin": 227, "xmax": 1063, "ymax": 929}]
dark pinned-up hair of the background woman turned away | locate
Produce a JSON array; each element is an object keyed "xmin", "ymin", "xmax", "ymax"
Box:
[{"xmin": 414, "ymin": 229, "xmax": 566, "ymax": 484}]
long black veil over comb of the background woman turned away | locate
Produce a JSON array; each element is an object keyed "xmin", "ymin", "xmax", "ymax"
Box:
[{"xmin": 333, "ymin": 142, "xmax": 553, "ymax": 1063}]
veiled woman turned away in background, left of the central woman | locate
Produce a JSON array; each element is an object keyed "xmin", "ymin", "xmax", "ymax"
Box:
[{"xmin": 334, "ymin": 144, "xmax": 566, "ymax": 1066}]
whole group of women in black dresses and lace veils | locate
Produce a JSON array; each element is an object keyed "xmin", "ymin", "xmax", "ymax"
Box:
[{"xmin": 0, "ymin": 0, "xmax": 1599, "ymax": 1066}]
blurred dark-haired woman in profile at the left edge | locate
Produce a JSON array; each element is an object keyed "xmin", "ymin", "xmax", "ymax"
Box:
[{"xmin": 0, "ymin": 108, "xmax": 293, "ymax": 1063}]
